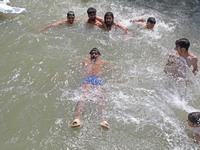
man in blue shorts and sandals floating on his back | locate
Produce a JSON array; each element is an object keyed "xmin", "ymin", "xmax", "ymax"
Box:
[{"xmin": 71, "ymin": 48, "xmax": 109, "ymax": 128}]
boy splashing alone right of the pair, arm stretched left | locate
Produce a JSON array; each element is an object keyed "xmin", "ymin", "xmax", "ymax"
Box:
[{"xmin": 130, "ymin": 17, "xmax": 156, "ymax": 30}]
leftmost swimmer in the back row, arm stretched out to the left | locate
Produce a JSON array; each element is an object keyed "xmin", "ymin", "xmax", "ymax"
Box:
[{"xmin": 36, "ymin": 11, "xmax": 79, "ymax": 32}]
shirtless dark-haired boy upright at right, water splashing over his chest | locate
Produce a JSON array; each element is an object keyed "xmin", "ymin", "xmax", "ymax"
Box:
[{"xmin": 164, "ymin": 38, "xmax": 198, "ymax": 78}]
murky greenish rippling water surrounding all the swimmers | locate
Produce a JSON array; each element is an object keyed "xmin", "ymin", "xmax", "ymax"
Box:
[{"xmin": 0, "ymin": 0, "xmax": 200, "ymax": 150}]
